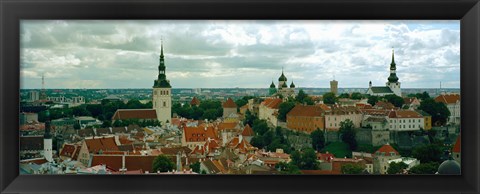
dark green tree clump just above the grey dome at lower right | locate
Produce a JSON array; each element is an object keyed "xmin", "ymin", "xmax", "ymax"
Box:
[{"xmin": 412, "ymin": 144, "xmax": 443, "ymax": 163}]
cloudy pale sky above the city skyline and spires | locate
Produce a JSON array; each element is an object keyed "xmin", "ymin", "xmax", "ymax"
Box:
[{"xmin": 20, "ymin": 20, "xmax": 460, "ymax": 88}]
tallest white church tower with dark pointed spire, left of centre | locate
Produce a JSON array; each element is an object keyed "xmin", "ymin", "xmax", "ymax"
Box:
[{"xmin": 152, "ymin": 41, "xmax": 172, "ymax": 126}]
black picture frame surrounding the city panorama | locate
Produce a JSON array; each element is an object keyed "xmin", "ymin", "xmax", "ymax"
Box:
[{"xmin": 0, "ymin": 0, "xmax": 480, "ymax": 193}]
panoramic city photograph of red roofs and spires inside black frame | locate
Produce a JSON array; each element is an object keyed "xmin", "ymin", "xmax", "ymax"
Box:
[{"xmin": 18, "ymin": 20, "xmax": 461, "ymax": 176}]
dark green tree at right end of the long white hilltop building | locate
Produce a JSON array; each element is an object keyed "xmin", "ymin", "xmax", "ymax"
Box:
[{"xmin": 418, "ymin": 98, "xmax": 450, "ymax": 124}]
